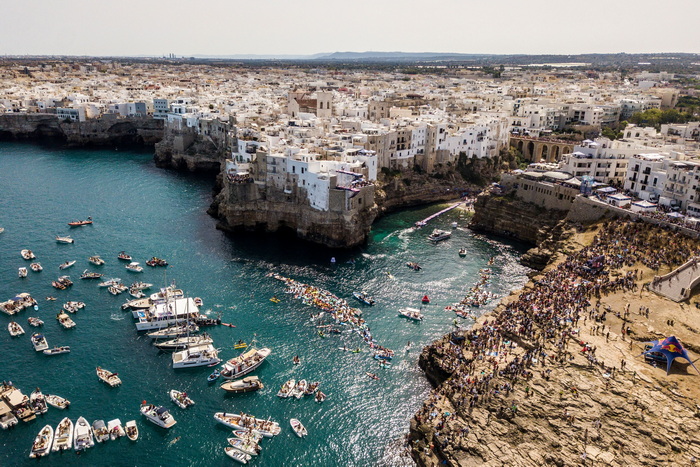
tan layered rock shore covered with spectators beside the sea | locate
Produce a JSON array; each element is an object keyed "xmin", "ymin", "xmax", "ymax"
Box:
[{"xmin": 407, "ymin": 222, "xmax": 700, "ymax": 466}]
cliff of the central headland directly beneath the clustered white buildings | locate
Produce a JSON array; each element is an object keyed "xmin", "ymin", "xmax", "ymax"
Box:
[{"xmin": 209, "ymin": 177, "xmax": 378, "ymax": 248}]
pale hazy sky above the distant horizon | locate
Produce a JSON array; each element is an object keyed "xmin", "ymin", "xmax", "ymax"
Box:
[{"xmin": 0, "ymin": 0, "xmax": 700, "ymax": 55}]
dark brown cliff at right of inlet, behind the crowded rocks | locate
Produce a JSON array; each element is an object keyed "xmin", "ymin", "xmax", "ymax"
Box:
[{"xmin": 469, "ymin": 192, "xmax": 567, "ymax": 247}]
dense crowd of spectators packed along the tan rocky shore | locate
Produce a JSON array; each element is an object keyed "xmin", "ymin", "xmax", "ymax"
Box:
[{"xmin": 415, "ymin": 220, "xmax": 700, "ymax": 458}]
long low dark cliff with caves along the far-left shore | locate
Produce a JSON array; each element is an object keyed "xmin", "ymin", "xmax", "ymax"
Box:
[{"xmin": 0, "ymin": 114, "xmax": 163, "ymax": 147}]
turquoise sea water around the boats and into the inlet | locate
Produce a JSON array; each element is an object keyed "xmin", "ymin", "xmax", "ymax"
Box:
[{"xmin": 0, "ymin": 143, "xmax": 527, "ymax": 466}]
